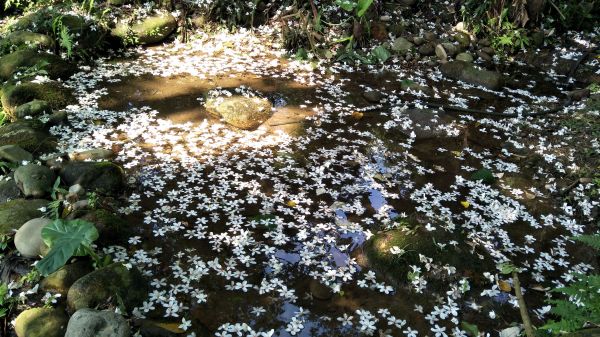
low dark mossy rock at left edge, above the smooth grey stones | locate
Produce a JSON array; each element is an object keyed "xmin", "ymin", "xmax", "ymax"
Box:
[{"xmin": 0, "ymin": 120, "xmax": 56, "ymax": 153}]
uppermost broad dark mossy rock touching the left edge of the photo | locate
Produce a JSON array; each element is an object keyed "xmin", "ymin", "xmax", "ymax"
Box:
[{"xmin": 0, "ymin": 49, "xmax": 76, "ymax": 81}]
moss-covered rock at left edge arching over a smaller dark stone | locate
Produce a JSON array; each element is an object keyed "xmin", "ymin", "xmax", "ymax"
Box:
[{"xmin": 0, "ymin": 82, "xmax": 76, "ymax": 115}]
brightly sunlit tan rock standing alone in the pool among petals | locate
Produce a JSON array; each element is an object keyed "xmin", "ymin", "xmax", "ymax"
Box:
[{"xmin": 205, "ymin": 96, "xmax": 273, "ymax": 130}]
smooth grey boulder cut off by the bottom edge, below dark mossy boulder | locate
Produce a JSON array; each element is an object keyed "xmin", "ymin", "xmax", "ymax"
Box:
[{"xmin": 64, "ymin": 308, "xmax": 130, "ymax": 337}]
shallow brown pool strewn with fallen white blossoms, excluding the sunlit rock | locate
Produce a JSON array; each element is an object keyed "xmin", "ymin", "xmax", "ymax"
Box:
[{"xmin": 49, "ymin": 37, "xmax": 585, "ymax": 336}]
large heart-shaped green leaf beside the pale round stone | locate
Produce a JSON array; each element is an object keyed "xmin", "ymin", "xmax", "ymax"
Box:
[{"xmin": 36, "ymin": 219, "xmax": 98, "ymax": 276}]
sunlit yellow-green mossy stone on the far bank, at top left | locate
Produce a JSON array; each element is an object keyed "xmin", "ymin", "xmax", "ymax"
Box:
[{"xmin": 111, "ymin": 13, "xmax": 177, "ymax": 45}]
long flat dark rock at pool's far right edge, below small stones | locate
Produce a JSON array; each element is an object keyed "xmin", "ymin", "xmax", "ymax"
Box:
[{"xmin": 440, "ymin": 61, "xmax": 504, "ymax": 90}]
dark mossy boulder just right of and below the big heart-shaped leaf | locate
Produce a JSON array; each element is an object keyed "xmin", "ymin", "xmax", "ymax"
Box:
[{"xmin": 67, "ymin": 263, "xmax": 148, "ymax": 312}]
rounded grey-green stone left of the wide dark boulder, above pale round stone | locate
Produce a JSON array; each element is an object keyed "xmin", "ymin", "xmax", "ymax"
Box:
[{"xmin": 15, "ymin": 164, "xmax": 56, "ymax": 198}]
